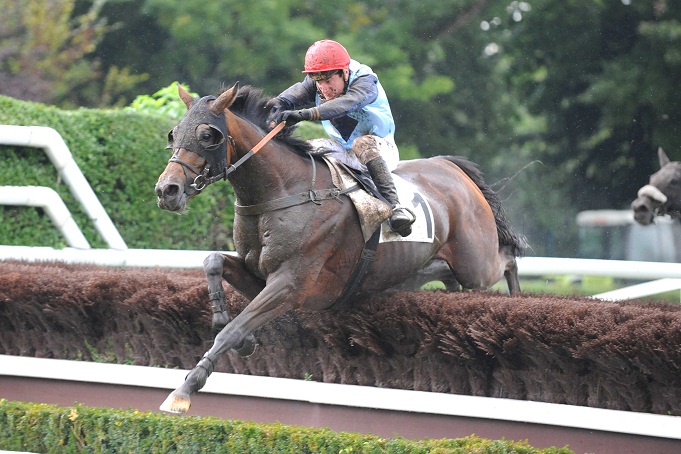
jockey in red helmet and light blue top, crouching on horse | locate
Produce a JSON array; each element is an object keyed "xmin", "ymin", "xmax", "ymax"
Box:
[{"xmin": 270, "ymin": 40, "xmax": 415, "ymax": 236}]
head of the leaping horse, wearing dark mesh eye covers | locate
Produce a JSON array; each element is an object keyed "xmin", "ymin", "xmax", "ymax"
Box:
[{"xmin": 155, "ymin": 84, "xmax": 238, "ymax": 211}]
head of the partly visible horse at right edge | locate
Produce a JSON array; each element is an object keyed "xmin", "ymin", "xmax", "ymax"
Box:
[{"xmin": 631, "ymin": 148, "xmax": 681, "ymax": 225}]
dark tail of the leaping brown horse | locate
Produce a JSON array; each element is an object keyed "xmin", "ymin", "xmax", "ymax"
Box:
[{"xmin": 442, "ymin": 156, "xmax": 527, "ymax": 257}]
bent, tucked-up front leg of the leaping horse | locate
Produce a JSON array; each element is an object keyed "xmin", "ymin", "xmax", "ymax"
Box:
[{"xmin": 203, "ymin": 252, "xmax": 265, "ymax": 356}]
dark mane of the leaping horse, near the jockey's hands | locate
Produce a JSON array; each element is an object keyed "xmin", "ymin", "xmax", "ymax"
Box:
[{"xmin": 218, "ymin": 85, "xmax": 311, "ymax": 154}]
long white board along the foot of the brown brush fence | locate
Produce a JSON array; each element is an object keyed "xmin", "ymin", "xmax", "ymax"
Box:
[{"xmin": 0, "ymin": 355, "xmax": 681, "ymax": 439}]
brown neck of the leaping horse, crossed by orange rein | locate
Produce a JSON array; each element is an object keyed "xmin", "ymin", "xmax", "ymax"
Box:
[{"xmin": 228, "ymin": 115, "xmax": 311, "ymax": 205}]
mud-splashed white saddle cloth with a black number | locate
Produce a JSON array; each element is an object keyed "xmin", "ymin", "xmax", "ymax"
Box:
[{"xmin": 323, "ymin": 156, "xmax": 435, "ymax": 243}]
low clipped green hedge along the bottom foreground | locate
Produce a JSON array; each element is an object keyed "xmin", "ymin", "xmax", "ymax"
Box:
[{"xmin": 0, "ymin": 399, "xmax": 572, "ymax": 454}]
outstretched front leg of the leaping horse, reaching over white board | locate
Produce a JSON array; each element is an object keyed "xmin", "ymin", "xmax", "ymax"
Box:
[{"xmin": 160, "ymin": 279, "xmax": 295, "ymax": 413}]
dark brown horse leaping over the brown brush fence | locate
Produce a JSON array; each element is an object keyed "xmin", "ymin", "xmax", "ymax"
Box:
[{"xmin": 155, "ymin": 83, "xmax": 526, "ymax": 413}]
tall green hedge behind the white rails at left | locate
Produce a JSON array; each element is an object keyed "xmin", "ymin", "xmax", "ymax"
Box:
[{"xmin": 0, "ymin": 96, "xmax": 233, "ymax": 250}]
